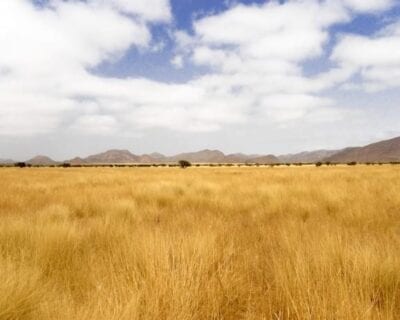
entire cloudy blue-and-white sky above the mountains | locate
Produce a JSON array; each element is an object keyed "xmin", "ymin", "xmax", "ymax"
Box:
[{"xmin": 0, "ymin": 0, "xmax": 400, "ymax": 160}]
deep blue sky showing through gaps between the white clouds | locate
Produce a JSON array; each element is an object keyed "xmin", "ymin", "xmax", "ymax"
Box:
[{"xmin": 94, "ymin": 0, "xmax": 400, "ymax": 82}]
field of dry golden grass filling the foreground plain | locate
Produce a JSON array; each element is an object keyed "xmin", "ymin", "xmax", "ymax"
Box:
[{"xmin": 0, "ymin": 166, "xmax": 400, "ymax": 320}]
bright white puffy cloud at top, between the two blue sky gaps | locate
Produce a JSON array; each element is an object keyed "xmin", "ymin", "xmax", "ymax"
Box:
[{"xmin": 191, "ymin": 1, "xmax": 348, "ymax": 61}]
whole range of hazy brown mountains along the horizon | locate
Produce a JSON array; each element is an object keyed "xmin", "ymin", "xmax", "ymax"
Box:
[{"xmin": 0, "ymin": 137, "xmax": 400, "ymax": 165}]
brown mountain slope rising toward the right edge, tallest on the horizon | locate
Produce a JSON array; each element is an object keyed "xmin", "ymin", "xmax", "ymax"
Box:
[{"xmin": 324, "ymin": 137, "xmax": 400, "ymax": 163}]
